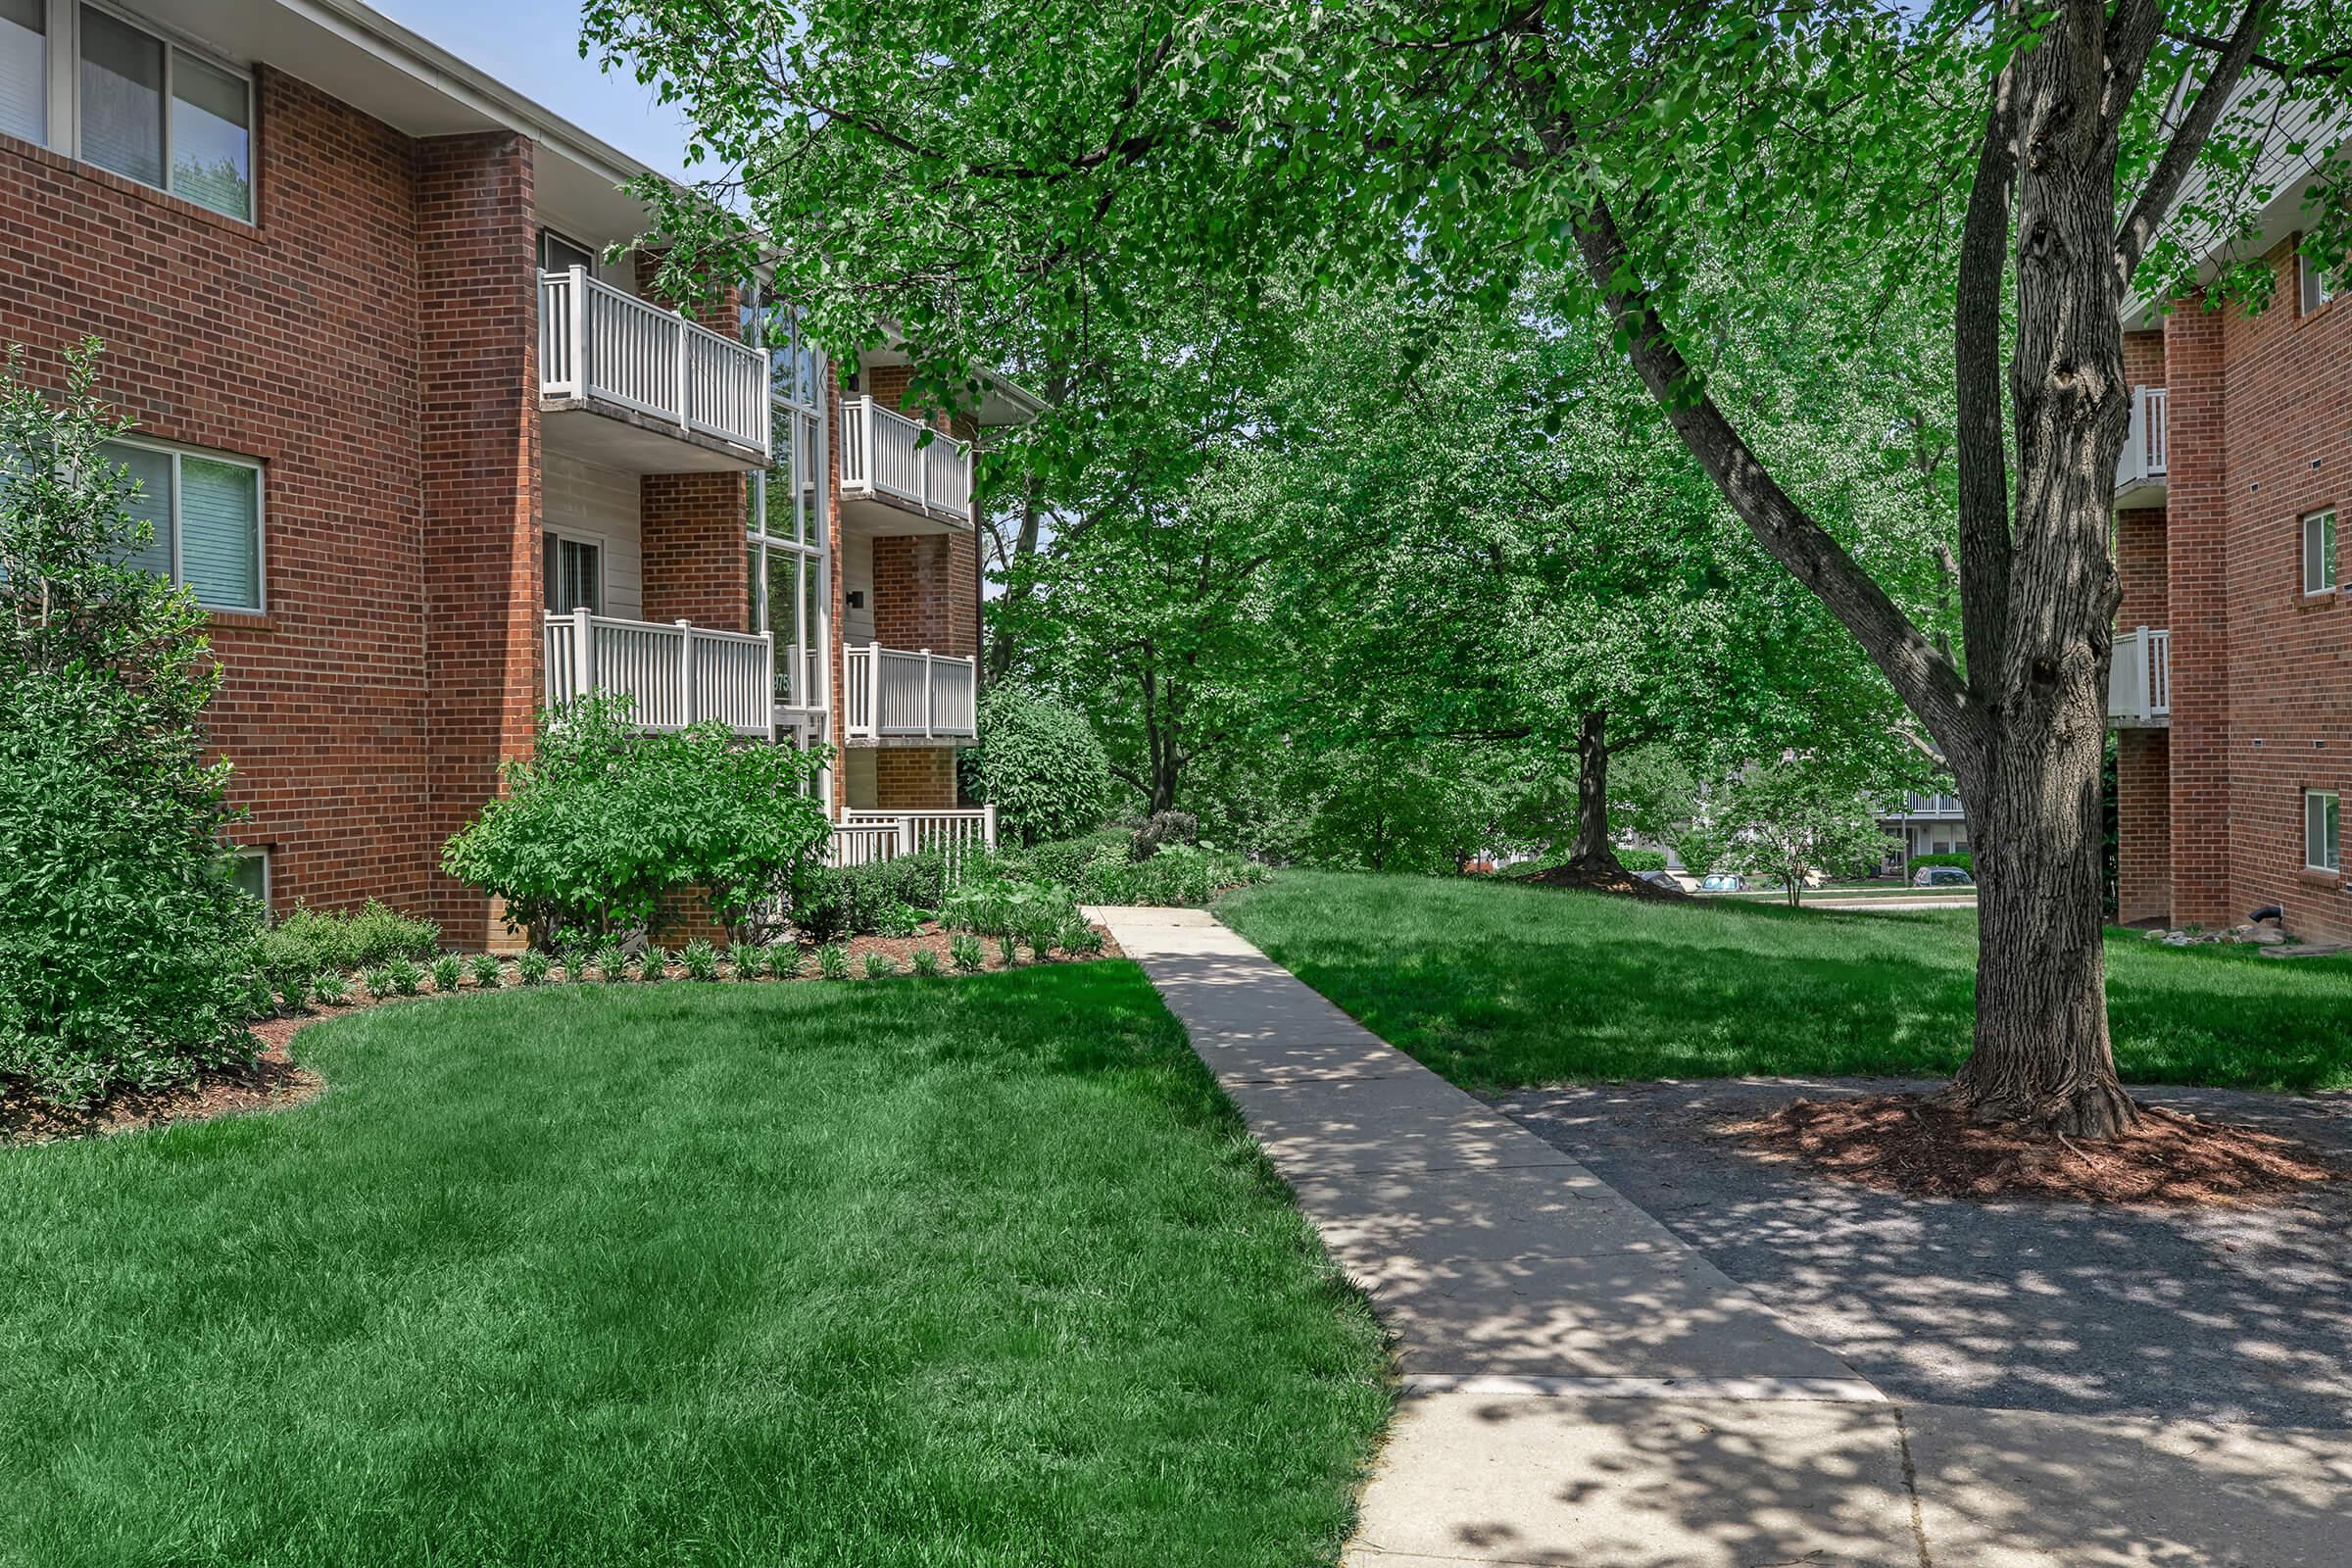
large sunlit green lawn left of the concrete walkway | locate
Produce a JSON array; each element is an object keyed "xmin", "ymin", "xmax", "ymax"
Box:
[{"xmin": 0, "ymin": 961, "xmax": 1388, "ymax": 1568}]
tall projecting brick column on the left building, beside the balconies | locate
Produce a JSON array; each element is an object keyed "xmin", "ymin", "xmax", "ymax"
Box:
[{"xmin": 416, "ymin": 131, "xmax": 543, "ymax": 948}]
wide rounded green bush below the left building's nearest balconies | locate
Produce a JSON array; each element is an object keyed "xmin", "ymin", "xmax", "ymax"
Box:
[{"xmin": 442, "ymin": 696, "xmax": 833, "ymax": 941}]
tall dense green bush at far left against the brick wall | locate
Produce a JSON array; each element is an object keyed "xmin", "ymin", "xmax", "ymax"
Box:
[{"xmin": 0, "ymin": 343, "xmax": 262, "ymax": 1104}]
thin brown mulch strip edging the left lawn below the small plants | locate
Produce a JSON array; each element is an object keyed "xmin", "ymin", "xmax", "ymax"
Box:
[{"xmin": 0, "ymin": 924, "xmax": 1124, "ymax": 1148}]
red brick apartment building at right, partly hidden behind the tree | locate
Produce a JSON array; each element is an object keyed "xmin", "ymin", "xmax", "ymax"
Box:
[{"xmin": 2107, "ymin": 120, "xmax": 2352, "ymax": 941}]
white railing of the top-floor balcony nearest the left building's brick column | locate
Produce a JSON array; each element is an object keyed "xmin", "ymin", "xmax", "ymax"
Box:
[{"xmin": 539, "ymin": 268, "xmax": 769, "ymax": 461}]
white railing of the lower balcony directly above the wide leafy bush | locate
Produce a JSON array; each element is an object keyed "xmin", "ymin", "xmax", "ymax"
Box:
[{"xmin": 546, "ymin": 609, "xmax": 776, "ymax": 738}]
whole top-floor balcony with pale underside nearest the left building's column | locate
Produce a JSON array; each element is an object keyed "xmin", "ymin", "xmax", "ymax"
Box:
[{"xmin": 539, "ymin": 268, "xmax": 771, "ymax": 472}]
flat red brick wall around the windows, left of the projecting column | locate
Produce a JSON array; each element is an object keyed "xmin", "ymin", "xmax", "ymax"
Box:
[{"xmin": 0, "ymin": 69, "xmax": 444, "ymax": 912}]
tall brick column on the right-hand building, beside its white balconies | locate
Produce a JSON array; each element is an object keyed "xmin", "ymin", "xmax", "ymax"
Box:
[{"xmin": 2164, "ymin": 299, "xmax": 2230, "ymax": 926}]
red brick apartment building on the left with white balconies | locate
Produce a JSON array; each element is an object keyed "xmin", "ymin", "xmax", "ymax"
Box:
[{"xmin": 0, "ymin": 0, "xmax": 1033, "ymax": 948}]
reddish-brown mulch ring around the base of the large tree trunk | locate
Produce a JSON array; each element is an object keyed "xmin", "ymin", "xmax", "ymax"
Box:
[{"xmin": 1717, "ymin": 1093, "xmax": 2352, "ymax": 1206}]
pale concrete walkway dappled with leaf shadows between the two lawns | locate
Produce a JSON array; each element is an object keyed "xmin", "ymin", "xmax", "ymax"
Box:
[{"xmin": 1089, "ymin": 909, "xmax": 2352, "ymax": 1568}]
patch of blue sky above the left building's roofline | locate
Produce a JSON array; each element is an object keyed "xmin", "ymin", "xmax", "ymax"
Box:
[{"xmin": 371, "ymin": 0, "xmax": 687, "ymax": 176}]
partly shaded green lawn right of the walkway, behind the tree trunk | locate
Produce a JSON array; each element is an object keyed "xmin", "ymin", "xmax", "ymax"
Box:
[{"xmin": 1218, "ymin": 872, "xmax": 2352, "ymax": 1089}]
